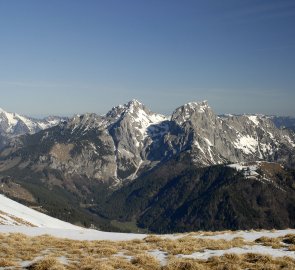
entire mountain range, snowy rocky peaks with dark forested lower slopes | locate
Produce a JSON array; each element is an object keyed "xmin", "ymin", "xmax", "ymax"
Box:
[{"xmin": 0, "ymin": 100, "xmax": 295, "ymax": 232}]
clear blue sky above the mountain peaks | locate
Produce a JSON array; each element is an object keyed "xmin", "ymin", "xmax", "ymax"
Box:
[{"xmin": 0, "ymin": 0, "xmax": 295, "ymax": 117}]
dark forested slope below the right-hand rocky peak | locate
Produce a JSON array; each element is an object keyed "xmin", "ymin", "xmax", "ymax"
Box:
[{"xmin": 97, "ymin": 159, "xmax": 295, "ymax": 233}]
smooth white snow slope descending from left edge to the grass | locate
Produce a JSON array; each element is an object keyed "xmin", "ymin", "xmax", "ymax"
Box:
[{"xmin": 0, "ymin": 194, "xmax": 145, "ymax": 240}]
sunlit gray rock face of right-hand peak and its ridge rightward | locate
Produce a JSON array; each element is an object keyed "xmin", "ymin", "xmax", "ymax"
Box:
[{"xmin": 171, "ymin": 102, "xmax": 295, "ymax": 166}]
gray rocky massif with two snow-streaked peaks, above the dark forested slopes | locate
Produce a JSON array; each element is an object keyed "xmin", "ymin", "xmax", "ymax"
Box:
[{"xmin": 1, "ymin": 100, "xmax": 295, "ymax": 187}]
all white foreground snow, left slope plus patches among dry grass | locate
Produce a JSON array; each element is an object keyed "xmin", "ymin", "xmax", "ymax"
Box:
[{"xmin": 0, "ymin": 195, "xmax": 295, "ymax": 265}]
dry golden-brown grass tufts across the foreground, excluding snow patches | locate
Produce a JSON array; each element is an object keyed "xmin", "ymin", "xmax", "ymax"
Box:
[{"xmin": 0, "ymin": 233, "xmax": 295, "ymax": 270}]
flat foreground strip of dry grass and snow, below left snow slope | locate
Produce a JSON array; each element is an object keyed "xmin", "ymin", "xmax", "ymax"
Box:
[{"xmin": 0, "ymin": 225, "xmax": 295, "ymax": 270}]
